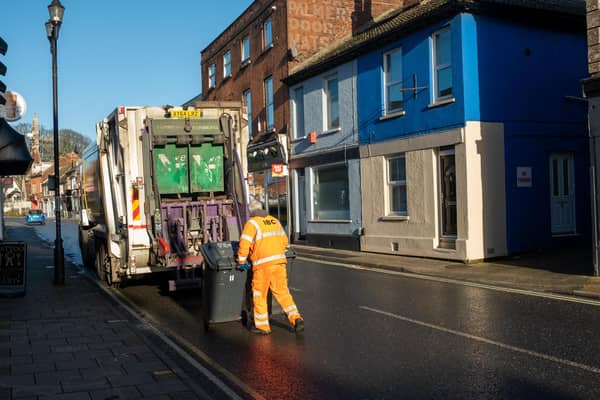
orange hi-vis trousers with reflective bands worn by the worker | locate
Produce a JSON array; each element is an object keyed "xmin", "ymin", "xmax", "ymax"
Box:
[{"xmin": 252, "ymin": 263, "xmax": 301, "ymax": 331}]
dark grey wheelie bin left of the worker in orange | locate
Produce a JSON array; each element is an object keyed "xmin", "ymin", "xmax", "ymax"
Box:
[{"xmin": 200, "ymin": 242, "xmax": 247, "ymax": 329}]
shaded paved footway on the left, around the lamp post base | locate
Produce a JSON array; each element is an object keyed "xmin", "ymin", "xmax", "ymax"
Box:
[{"xmin": 0, "ymin": 223, "xmax": 216, "ymax": 400}]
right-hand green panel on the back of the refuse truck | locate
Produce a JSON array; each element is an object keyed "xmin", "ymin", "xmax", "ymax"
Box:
[{"xmin": 190, "ymin": 143, "xmax": 224, "ymax": 192}]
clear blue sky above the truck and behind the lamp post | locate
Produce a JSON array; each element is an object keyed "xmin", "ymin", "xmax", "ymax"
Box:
[{"xmin": 0, "ymin": 0, "xmax": 252, "ymax": 138}]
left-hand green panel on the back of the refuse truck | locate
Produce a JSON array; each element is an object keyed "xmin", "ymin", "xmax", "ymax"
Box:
[{"xmin": 153, "ymin": 144, "xmax": 190, "ymax": 194}]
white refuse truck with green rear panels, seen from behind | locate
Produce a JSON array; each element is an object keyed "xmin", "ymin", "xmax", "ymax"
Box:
[{"xmin": 79, "ymin": 102, "xmax": 248, "ymax": 291}]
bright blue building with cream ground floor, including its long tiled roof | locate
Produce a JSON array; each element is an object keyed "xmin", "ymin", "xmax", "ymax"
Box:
[{"xmin": 288, "ymin": 0, "xmax": 591, "ymax": 261}]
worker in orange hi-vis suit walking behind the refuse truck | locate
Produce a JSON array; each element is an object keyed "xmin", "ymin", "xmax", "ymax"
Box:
[{"xmin": 238, "ymin": 205, "xmax": 304, "ymax": 335}]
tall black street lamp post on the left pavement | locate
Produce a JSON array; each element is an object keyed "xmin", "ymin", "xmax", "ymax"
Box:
[{"xmin": 46, "ymin": 0, "xmax": 65, "ymax": 285}]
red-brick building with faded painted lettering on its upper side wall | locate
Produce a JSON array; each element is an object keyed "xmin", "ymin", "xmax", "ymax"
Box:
[{"xmin": 201, "ymin": 0, "xmax": 404, "ymax": 230}]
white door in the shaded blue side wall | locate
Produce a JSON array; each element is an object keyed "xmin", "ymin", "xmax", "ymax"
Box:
[{"xmin": 550, "ymin": 153, "xmax": 576, "ymax": 235}]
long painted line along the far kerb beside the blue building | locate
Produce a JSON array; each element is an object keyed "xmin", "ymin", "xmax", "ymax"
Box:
[{"xmin": 297, "ymin": 256, "xmax": 600, "ymax": 306}]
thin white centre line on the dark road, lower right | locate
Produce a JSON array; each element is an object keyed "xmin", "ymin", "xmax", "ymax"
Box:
[{"xmin": 358, "ymin": 306, "xmax": 600, "ymax": 374}]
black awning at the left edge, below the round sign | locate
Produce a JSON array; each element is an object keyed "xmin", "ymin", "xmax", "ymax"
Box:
[{"xmin": 0, "ymin": 118, "xmax": 33, "ymax": 176}]
